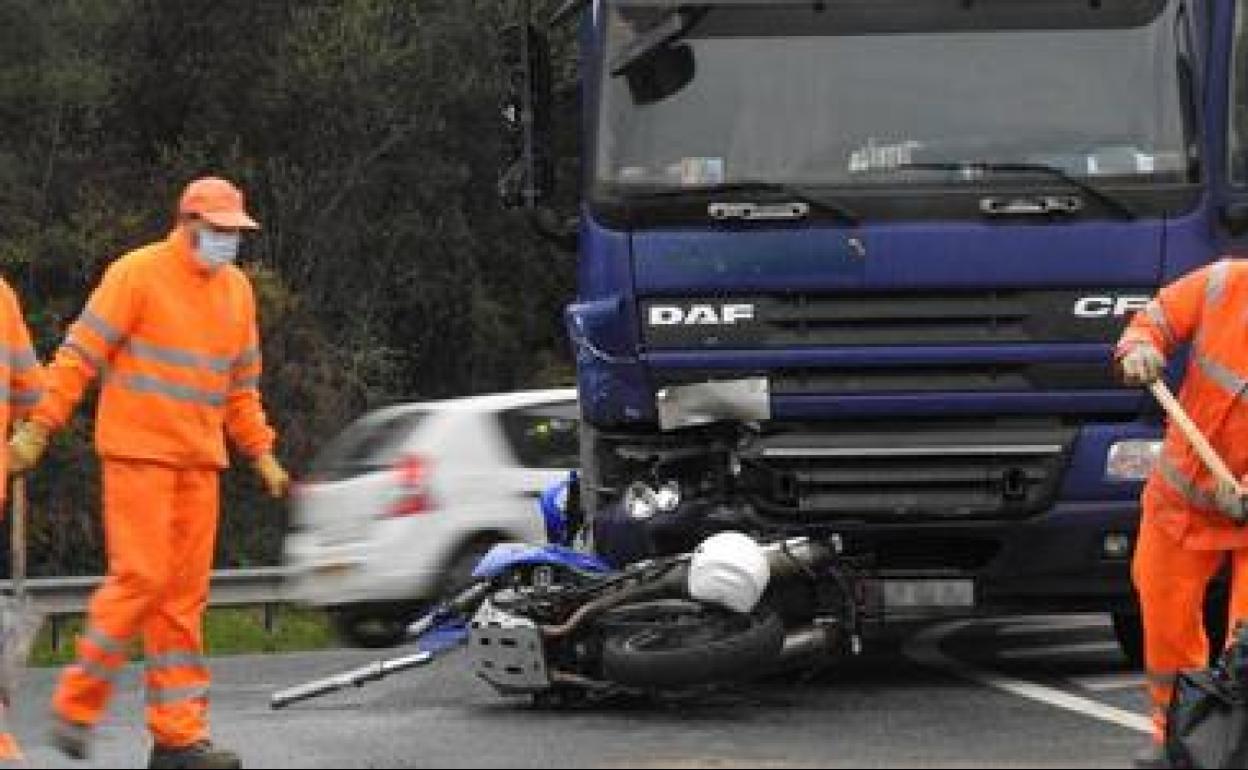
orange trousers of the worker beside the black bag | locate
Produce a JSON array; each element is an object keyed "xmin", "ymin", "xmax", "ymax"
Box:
[{"xmin": 1132, "ymin": 494, "xmax": 1248, "ymax": 741}]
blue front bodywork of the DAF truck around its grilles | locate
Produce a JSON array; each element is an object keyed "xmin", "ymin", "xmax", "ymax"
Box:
[{"xmin": 567, "ymin": 0, "xmax": 1248, "ymax": 610}]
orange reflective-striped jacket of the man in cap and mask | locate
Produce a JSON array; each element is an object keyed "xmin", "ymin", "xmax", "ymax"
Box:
[{"xmin": 31, "ymin": 228, "xmax": 275, "ymax": 468}]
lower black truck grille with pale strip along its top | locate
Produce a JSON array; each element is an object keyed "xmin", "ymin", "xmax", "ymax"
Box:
[{"xmin": 743, "ymin": 421, "xmax": 1076, "ymax": 522}]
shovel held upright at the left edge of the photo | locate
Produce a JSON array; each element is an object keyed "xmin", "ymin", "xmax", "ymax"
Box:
[{"xmin": 0, "ymin": 475, "xmax": 42, "ymax": 706}]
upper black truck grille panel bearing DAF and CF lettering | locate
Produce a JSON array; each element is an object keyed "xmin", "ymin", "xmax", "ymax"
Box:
[{"xmin": 641, "ymin": 288, "xmax": 1152, "ymax": 349}]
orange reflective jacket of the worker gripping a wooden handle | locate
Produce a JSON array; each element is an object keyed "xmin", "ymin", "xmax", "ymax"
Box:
[{"xmin": 1118, "ymin": 260, "xmax": 1248, "ymax": 550}]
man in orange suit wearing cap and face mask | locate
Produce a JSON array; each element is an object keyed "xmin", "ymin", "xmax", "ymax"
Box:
[{"xmin": 10, "ymin": 178, "xmax": 290, "ymax": 768}]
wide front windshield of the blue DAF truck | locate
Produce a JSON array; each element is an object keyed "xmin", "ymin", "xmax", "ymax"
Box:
[{"xmin": 595, "ymin": 0, "xmax": 1197, "ymax": 195}]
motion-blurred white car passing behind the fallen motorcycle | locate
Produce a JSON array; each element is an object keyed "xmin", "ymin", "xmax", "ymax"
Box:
[{"xmin": 286, "ymin": 389, "xmax": 578, "ymax": 646}]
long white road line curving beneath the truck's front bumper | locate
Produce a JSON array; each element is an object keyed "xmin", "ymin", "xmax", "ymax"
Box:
[{"xmin": 905, "ymin": 620, "xmax": 1153, "ymax": 735}]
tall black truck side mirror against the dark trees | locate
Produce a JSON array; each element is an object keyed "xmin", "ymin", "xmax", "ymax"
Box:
[{"xmin": 498, "ymin": 24, "xmax": 554, "ymax": 208}]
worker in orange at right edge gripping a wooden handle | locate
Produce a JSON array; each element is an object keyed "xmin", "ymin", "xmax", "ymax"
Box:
[{"xmin": 1117, "ymin": 260, "xmax": 1248, "ymax": 768}]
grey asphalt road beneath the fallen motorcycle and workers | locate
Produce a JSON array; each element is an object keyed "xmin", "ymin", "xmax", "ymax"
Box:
[{"xmin": 15, "ymin": 616, "xmax": 1147, "ymax": 768}]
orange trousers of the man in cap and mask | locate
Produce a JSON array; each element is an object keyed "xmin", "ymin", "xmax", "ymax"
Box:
[{"xmin": 52, "ymin": 458, "xmax": 220, "ymax": 748}]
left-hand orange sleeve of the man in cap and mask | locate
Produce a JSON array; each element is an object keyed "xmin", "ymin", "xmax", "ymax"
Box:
[{"xmin": 30, "ymin": 261, "xmax": 142, "ymax": 432}]
